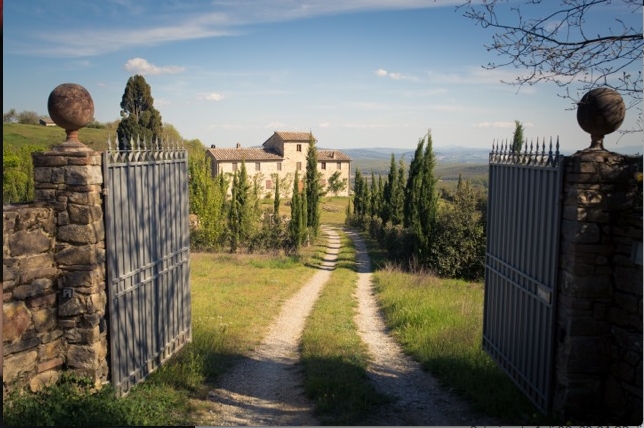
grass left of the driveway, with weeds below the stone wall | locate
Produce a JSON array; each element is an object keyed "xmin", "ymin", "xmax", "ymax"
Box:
[{"xmin": 2, "ymin": 253, "xmax": 314, "ymax": 426}]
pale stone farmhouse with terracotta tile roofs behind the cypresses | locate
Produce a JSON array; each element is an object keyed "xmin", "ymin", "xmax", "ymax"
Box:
[{"xmin": 207, "ymin": 131, "xmax": 351, "ymax": 197}]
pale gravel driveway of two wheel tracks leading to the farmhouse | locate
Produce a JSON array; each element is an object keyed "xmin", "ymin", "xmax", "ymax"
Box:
[{"xmin": 201, "ymin": 227, "xmax": 499, "ymax": 426}]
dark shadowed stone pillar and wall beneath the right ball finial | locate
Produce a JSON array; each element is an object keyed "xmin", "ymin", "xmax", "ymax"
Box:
[{"xmin": 553, "ymin": 150, "xmax": 642, "ymax": 425}]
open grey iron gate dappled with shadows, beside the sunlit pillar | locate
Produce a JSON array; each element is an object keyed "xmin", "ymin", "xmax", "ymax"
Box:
[{"xmin": 103, "ymin": 139, "xmax": 192, "ymax": 395}]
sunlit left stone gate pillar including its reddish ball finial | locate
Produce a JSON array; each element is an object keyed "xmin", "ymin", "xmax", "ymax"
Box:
[{"xmin": 33, "ymin": 84, "xmax": 108, "ymax": 386}]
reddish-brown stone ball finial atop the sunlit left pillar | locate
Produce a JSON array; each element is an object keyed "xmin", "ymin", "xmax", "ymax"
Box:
[{"xmin": 47, "ymin": 83, "xmax": 94, "ymax": 151}]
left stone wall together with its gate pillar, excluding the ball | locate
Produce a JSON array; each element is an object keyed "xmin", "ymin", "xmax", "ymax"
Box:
[{"xmin": 2, "ymin": 146, "xmax": 108, "ymax": 399}]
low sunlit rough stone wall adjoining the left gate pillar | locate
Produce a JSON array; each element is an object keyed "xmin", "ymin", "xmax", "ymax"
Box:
[{"xmin": 2, "ymin": 205, "xmax": 64, "ymax": 397}]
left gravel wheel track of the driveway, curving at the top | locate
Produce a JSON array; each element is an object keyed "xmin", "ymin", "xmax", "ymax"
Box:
[{"xmin": 210, "ymin": 228, "xmax": 340, "ymax": 426}]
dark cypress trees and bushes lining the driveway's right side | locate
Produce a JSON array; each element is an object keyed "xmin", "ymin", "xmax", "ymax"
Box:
[{"xmin": 347, "ymin": 133, "xmax": 485, "ymax": 279}]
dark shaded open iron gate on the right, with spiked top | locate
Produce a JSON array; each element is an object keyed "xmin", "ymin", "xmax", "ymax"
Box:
[{"xmin": 483, "ymin": 140, "xmax": 563, "ymax": 412}]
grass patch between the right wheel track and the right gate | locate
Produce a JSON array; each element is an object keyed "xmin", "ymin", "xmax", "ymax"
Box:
[{"xmin": 374, "ymin": 260, "xmax": 560, "ymax": 425}]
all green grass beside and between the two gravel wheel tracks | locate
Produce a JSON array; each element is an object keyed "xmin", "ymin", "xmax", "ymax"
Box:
[{"xmin": 3, "ymin": 224, "xmax": 561, "ymax": 426}]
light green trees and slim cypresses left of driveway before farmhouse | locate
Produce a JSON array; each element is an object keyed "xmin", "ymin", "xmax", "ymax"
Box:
[{"xmin": 189, "ymin": 136, "xmax": 322, "ymax": 253}]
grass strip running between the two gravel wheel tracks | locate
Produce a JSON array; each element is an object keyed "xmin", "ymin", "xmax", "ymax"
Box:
[{"xmin": 301, "ymin": 229, "xmax": 385, "ymax": 425}]
